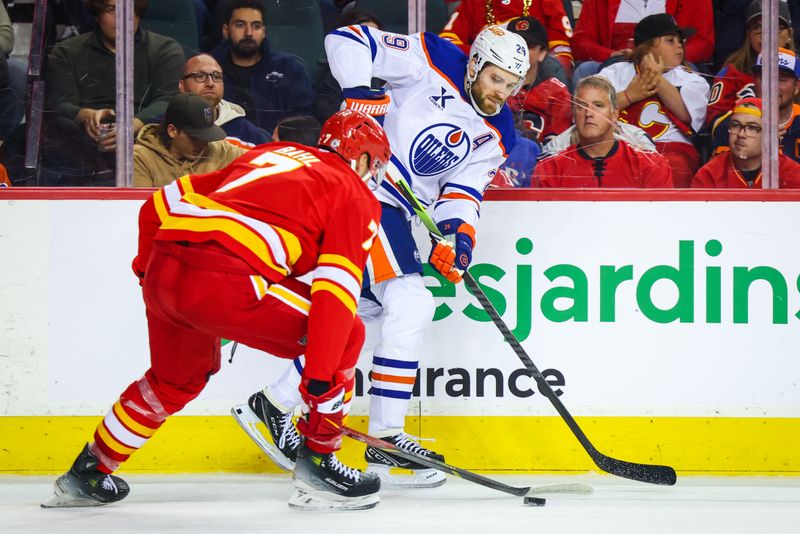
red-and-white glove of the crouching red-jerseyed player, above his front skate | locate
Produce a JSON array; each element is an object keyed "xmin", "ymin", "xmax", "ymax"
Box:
[{"xmin": 297, "ymin": 379, "xmax": 347, "ymax": 454}]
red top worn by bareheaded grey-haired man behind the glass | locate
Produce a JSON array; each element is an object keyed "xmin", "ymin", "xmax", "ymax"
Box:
[{"xmin": 534, "ymin": 141, "xmax": 672, "ymax": 188}]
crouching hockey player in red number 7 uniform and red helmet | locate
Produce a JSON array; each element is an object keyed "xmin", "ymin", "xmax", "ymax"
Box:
[{"xmin": 44, "ymin": 110, "xmax": 390, "ymax": 509}]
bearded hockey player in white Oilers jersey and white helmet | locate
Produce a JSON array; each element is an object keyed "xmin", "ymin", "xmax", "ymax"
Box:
[{"xmin": 233, "ymin": 26, "xmax": 529, "ymax": 487}]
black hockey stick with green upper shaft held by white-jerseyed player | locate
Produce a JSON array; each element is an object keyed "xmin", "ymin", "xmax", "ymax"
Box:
[{"xmin": 395, "ymin": 178, "xmax": 677, "ymax": 486}]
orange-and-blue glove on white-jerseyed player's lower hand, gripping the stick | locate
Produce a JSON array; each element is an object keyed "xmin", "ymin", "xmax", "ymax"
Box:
[{"xmin": 428, "ymin": 219, "xmax": 475, "ymax": 284}]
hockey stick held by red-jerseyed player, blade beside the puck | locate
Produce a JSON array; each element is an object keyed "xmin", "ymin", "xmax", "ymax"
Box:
[{"xmin": 342, "ymin": 426, "xmax": 593, "ymax": 497}]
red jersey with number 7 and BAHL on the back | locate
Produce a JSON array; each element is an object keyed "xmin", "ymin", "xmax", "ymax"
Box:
[{"xmin": 133, "ymin": 143, "xmax": 380, "ymax": 368}]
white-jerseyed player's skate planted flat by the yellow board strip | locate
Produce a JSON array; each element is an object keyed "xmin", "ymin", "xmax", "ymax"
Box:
[{"xmin": 364, "ymin": 432, "xmax": 447, "ymax": 488}]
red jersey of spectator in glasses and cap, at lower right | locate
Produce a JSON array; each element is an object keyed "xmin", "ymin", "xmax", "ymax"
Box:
[{"xmin": 692, "ymin": 152, "xmax": 800, "ymax": 189}]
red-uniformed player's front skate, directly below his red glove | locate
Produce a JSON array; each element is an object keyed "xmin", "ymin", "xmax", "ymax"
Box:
[{"xmin": 289, "ymin": 445, "xmax": 381, "ymax": 510}]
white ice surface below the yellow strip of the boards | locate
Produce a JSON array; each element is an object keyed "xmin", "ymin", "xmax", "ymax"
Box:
[{"xmin": 0, "ymin": 474, "xmax": 800, "ymax": 534}]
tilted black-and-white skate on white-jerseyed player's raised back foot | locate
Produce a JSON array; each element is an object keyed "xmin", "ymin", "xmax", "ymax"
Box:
[{"xmin": 236, "ymin": 391, "xmax": 300, "ymax": 471}]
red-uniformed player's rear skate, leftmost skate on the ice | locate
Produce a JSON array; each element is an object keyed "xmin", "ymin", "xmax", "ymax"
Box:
[{"xmin": 42, "ymin": 444, "xmax": 130, "ymax": 508}]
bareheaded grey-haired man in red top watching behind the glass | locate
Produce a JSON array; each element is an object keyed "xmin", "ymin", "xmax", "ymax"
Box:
[{"xmin": 534, "ymin": 76, "xmax": 672, "ymax": 188}]
